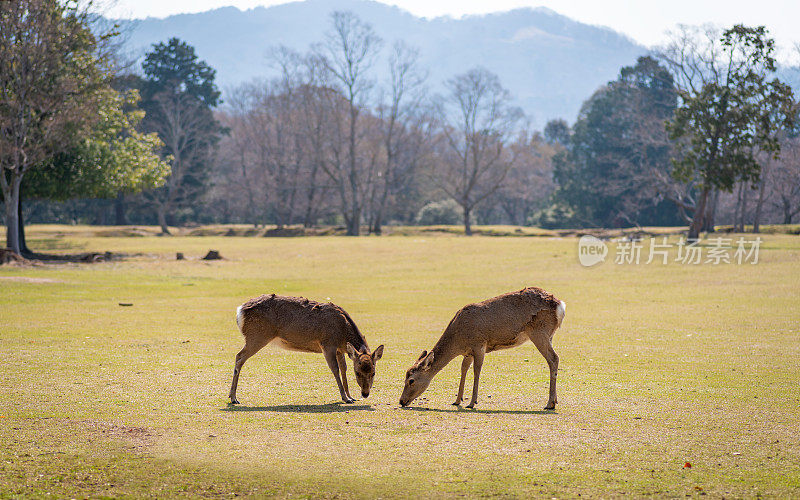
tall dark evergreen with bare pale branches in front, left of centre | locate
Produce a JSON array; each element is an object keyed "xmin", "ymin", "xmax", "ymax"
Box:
[{"xmin": 142, "ymin": 38, "xmax": 223, "ymax": 234}]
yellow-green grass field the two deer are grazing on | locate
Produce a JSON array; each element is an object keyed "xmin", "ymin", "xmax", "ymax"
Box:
[{"xmin": 0, "ymin": 226, "xmax": 800, "ymax": 498}]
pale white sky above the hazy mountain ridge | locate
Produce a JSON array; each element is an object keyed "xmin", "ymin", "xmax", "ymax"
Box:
[{"xmin": 109, "ymin": 0, "xmax": 800, "ymax": 51}]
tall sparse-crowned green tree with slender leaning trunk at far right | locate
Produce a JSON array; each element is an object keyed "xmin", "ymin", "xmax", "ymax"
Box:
[{"xmin": 661, "ymin": 25, "xmax": 793, "ymax": 239}]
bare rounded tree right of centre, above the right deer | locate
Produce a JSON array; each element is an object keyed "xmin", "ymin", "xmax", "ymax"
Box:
[{"xmin": 434, "ymin": 68, "xmax": 522, "ymax": 236}]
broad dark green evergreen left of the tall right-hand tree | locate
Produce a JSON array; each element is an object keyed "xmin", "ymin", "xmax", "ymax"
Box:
[{"xmin": 545, "ymin": 57, "xmax": 678, "ymax": 226}]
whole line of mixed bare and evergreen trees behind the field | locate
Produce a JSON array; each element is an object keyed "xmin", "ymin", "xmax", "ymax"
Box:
[{"xmin": 0, "ymin": 0, "xmax": 800, "ymax": 248}]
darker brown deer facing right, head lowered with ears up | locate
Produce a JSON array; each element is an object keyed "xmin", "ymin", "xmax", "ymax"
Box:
[{"xmin": 228, "ymin": 293, "xmax": 383, "ymax": 404}]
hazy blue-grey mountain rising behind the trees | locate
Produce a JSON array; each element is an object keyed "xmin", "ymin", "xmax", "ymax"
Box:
[{"xmin": 115, "ymin": 0, "xmax": 647, "ymax": 127}]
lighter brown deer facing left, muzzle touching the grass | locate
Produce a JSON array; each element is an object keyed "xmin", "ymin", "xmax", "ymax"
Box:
[{"xmin": 400, "ymin": 288, "xmax": 567, "ymax": 410}]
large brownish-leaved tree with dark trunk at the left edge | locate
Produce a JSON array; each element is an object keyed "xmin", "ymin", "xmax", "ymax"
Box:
[{"xmin": 0, "ymin": 0, "xmax": 105, "ymax": 252}]
